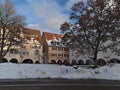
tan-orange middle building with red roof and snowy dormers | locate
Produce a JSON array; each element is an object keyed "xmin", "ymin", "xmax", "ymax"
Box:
[{"xmin": 42, "ymin": 32, "xmax": 69, "ymax": 63}]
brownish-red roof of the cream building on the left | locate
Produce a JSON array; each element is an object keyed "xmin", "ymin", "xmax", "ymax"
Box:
[{"xmin": 23, "ymin": 28, "xmax": 42, "ymax": 44}]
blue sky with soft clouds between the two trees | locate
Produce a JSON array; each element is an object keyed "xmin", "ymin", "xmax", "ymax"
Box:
[{"xmin": 10, "ymin": 0, "xmax": 80, "ymax": 33}]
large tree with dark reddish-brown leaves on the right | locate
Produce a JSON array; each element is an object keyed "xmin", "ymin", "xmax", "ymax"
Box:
[{"xmin": 60, "ymin": 0, "xmax": 120, "ymax": 67}]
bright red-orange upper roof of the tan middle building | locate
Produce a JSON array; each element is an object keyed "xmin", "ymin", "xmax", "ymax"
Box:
[{"xmin": 43, "ymin": 32, "xmax": 63, "ymax": 41}]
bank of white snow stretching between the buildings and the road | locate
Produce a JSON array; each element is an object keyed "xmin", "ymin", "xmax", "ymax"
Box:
[{"xmin": 0, "ymin": 63, "xmax": 120, "ymax": 80}]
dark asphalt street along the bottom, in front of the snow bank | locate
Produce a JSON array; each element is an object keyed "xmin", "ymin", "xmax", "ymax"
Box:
[{"xmin": 0, "ymin": 79, "xmax": 120, "ymax": 90}]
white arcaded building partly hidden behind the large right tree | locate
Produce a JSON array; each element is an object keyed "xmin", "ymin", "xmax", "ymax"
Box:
[{"xmin": 69, "ymin": 40, "xmax": 120, "ymax": 64}]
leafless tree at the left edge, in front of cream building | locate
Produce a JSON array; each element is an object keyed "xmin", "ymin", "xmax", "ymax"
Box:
[{"xmin": 0, "ymin": 0, "xmax": 24, "ymax": 62}]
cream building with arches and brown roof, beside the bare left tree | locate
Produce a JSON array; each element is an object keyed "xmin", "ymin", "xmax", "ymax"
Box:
[{"xmin": 4, "ymin": 28, "xmax": 43, "ymax": 63}]
